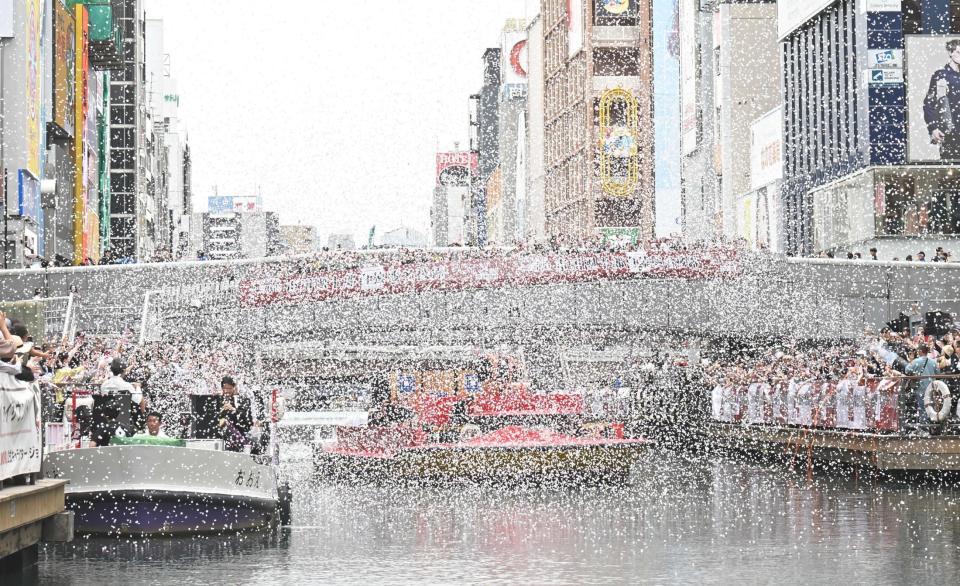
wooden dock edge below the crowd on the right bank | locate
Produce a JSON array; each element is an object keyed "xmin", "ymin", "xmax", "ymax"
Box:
[{"xmin": 707, "ymin": 423, "xmax": 960, "ymax": 472}]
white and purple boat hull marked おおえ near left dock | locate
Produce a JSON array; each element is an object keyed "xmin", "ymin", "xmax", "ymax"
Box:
[{"xmin": 43, "ymin": 446, "xmax": 278, "ymax": 535}]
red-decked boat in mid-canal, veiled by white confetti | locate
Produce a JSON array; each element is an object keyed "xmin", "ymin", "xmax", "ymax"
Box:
[{"xmin": 315, "ymin": 383, "xmax": 651, "ymax": 482}]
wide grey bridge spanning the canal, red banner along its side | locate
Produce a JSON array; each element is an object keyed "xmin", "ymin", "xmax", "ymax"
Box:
[{"xmin": 0, "ymin": 250, "xmax": 948, "ymax": 347}]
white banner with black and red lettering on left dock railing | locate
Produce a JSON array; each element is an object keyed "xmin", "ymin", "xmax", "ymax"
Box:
[{"xmin": 0, "ymin": 389, "xmax": 42, "ymax": 481}]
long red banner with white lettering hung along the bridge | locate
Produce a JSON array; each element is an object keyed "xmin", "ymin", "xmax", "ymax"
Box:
[{"xmin": 240, "ymin": 251, "xmax": 740, "ymax": 307}]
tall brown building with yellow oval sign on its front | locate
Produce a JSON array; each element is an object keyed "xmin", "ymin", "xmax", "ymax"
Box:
[{"xmin": 541, "ymin": 0, "xmax": 655, "ymax": 239}]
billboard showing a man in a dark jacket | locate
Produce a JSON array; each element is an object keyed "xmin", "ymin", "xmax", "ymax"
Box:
[{"xmin": 904, "ymin": 35, "xmax": 960, "ymax": 163}]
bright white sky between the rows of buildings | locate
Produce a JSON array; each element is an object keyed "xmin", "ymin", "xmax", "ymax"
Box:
[{"xmin": 145, "ymin": 0, "xmax": 526, "ymax": 242}]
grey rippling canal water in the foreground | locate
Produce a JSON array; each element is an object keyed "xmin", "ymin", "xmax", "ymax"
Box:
[{"xmin": 38, "ymin": 453, "xmax": 960, "ymax": 586}]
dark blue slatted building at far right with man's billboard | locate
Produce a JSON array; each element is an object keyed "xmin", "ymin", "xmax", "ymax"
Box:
[{"xmin": 778, "ymin": 0, "xmax": 960, "ymax": 258}]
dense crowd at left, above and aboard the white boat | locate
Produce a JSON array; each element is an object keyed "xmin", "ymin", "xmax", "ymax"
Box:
[{"xmin": 14, "ymin": 328, "xmax": 267, "ymax": 451}]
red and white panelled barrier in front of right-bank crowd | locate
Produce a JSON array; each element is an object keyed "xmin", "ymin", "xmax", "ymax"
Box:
[{"xmin": 710, "ymin": 378, "xmax": 909, "ymax": 433}]
